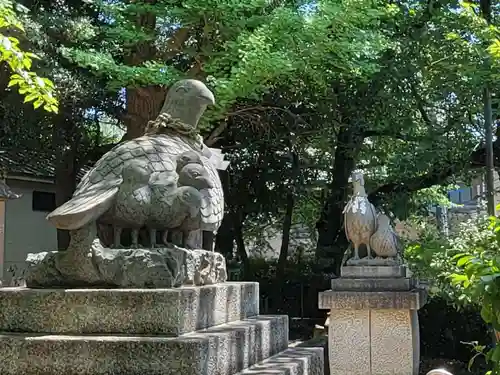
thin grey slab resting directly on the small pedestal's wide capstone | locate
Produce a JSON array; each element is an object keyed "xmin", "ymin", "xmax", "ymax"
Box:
[{"xmin": 332, "ymin": 277, "xmax": 412, "ymax": 292}]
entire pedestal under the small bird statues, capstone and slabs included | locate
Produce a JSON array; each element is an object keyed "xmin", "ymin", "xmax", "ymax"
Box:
[{"xmin": 319, "ymin": 266, "xmax": 426, "ymax": 375}]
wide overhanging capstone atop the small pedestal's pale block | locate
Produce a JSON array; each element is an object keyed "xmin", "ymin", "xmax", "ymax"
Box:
[{"xmin": 318, "ymin": 290, "xmax": 426, "ymax": 310}]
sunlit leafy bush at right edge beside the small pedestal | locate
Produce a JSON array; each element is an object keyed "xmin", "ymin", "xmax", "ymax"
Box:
[{"xmin": 405, "ymin": 213, "xmax": 500, "ymax": 374}]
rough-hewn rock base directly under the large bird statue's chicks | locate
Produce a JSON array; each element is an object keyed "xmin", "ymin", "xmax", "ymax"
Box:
[{"xmin": 26, "ymin": 239, "xmax": 227, "ymax": 288}]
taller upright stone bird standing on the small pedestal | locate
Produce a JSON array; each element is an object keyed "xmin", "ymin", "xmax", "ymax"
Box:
[{"xmin": 343, "ymin": 172, "xmax": 377, "ymax": 260}]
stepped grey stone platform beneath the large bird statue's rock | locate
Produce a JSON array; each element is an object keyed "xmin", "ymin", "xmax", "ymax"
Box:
[{"xmin": 0, "ymin": 282, "xmax": 323, "ymax": 375}]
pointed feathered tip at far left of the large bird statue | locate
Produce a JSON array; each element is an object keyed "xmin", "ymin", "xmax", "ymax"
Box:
[{"xmin": 47, "ymin": 187, "xmax": 118, "ymax": 230}]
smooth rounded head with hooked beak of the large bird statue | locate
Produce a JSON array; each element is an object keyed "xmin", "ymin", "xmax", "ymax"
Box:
[{"xmin": 160, "ymin": 79, "xmax": 215, "ymax": 128}]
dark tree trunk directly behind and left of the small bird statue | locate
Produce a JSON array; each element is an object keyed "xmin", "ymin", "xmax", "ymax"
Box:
[{"xmin": 316, "ymin": 126, "xmax": 363, "ymax": 275}]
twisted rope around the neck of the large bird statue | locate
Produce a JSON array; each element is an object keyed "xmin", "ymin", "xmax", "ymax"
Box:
[{"xmin": 144, "ymin": 112, "xmax": 203, "ymax": 150}]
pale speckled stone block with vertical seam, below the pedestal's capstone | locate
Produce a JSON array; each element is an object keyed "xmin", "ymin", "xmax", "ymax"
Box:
[{"xmin": 328, "ymin": 309, "xmax": 420, "ymax": 375}]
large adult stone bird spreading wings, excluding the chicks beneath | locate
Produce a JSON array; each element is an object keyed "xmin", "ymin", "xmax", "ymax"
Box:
[{"xmin": 47, "ymin": 79, "xmax": 224, "ymax": 248}]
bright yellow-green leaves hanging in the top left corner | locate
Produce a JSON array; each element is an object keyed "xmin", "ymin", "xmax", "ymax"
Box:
[{"xmin": 0, "ymin": 0, "xmax": 58, "ymax": 113}]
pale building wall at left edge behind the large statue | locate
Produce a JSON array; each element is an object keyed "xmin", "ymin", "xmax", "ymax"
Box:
[{"xmin": 0, "ymin": 180, "xmax": 57, "ymax": 281}]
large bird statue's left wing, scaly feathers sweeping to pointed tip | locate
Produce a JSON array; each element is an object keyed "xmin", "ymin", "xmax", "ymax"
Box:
[{"xmin": 47, "ymin": 136, "xmax": 176, "ymax": 230}]
